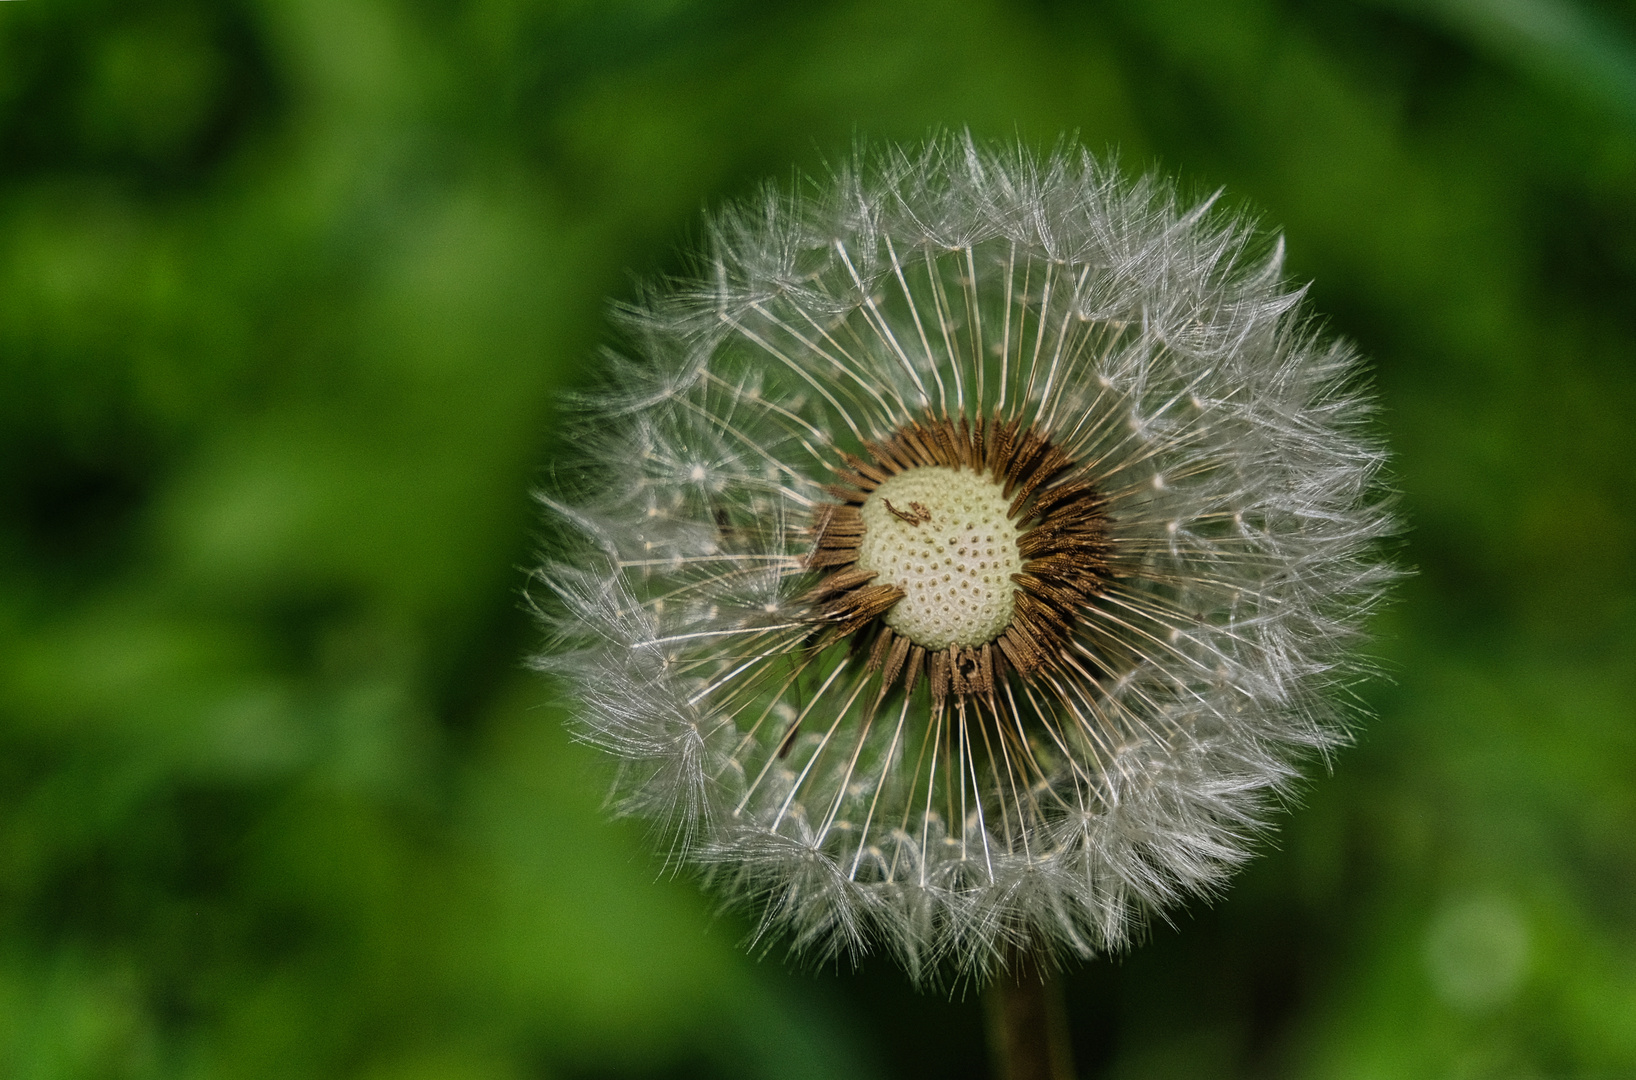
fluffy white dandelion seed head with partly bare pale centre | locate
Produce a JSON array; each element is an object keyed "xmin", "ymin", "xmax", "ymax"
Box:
[{"xmin": 537, "ymin": 137, "xmax": 1392, "ymax": 1080}]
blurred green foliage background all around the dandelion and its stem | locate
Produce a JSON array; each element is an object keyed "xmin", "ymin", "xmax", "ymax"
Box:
[{"xmin": 0, "ymin": 0, "xmax": 1636, "ymax": 1080}]
